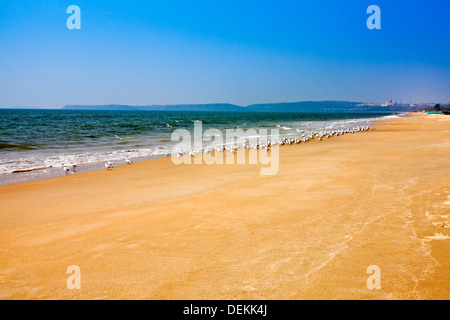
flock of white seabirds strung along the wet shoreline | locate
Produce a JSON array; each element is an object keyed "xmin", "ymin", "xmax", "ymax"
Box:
[{"xmin": 62, "ymin": 126, "xmax": 374, "ymax": 174}]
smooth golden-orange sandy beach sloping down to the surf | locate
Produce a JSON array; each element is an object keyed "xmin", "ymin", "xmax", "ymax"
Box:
[{"xmin": 0, "ymin": 114, "xmax": 450, "ymax": 299}]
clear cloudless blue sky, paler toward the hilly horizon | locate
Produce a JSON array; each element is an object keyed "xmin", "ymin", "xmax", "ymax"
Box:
[{"xmin": 0, "ymin": 0, "xmax": 450, "ymax": 107}]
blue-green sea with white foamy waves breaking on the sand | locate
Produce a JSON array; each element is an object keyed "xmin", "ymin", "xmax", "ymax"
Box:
[{"xmin": 0, "ymin": 109, "xmax": 397, "ymax": 184}]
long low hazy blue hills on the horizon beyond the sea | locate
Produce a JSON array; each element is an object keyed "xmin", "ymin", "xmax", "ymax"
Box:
[{"xmin": 63, "ymin": 101, "xmax": 412, "ymax": 112}]
